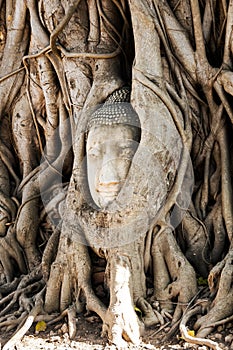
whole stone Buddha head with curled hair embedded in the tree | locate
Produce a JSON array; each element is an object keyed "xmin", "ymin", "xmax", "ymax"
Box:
[{"xmin": 86, "ymin": 88, "xmax": 140, "ymax": 209}]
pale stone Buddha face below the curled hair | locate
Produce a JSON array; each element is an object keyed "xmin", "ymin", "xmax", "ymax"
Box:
[{"xmin": 86, "ymin": 124, "xmax": 138, "ymax": 208}]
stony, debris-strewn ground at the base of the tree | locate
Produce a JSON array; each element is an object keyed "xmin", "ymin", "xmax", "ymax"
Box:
[{"xmin": 0, "ymin": 314, "xmax": 233, "ymax": 350}]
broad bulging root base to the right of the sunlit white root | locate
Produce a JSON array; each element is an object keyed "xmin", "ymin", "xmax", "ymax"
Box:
[{"xmin": 152, "ymin": 229, "xmax": 197, "ymax": 323}]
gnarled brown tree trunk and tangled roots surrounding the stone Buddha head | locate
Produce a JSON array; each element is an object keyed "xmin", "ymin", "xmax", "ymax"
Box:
[{"xmin": 0, "ymin": 0, "xmax": 233, "ymax": 349}]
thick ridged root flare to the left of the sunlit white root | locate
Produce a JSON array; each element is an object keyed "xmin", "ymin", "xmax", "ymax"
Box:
[{"xmin": 45, "ymin": 231, "xmax": 106, "ymax": 319}]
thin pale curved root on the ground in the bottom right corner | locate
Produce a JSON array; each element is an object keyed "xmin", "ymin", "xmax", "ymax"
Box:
[{"xmin": 179, "ymin": 305, "xmax": 222, "ymax": 350}]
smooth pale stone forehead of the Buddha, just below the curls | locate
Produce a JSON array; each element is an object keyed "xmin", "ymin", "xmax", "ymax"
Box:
[{"xmin": 87, "ymin": 124, "xmax": 135, "ymax": 146}]
